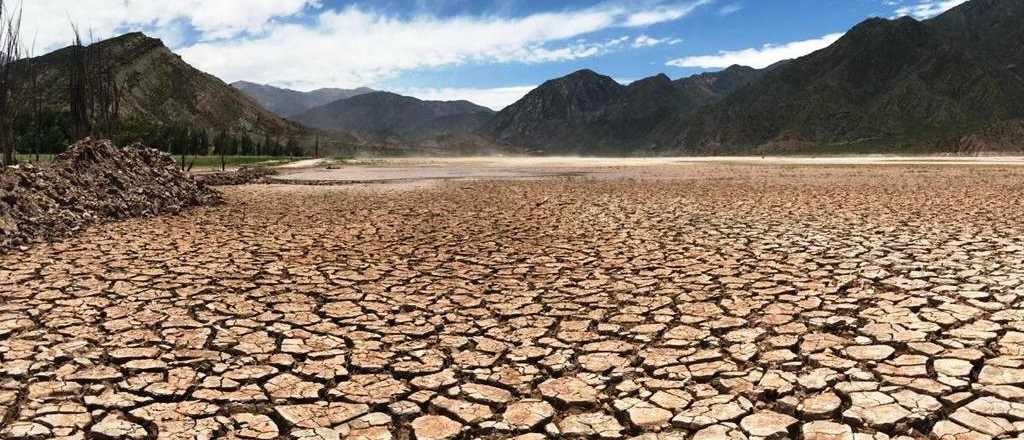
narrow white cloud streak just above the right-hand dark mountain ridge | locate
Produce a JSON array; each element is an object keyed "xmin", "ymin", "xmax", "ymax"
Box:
[{"xmin": 668, "ymin": 34, "xmax": 843, "ymax": 69}]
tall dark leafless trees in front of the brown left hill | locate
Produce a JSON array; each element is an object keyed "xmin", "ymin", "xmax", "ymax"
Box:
[{"xmin": 68, "ymin": 24, "xmax": 121, "ymax": 139}]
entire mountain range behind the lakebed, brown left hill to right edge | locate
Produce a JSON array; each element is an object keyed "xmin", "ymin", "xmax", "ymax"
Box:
[{"xmin": 9, "ymin": 0, "xmax": 1024, "ymax": 155}]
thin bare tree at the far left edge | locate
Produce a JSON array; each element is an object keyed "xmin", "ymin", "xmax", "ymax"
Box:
[{"xmin": 0, "ymin": 0, "xmax": 22, "ymax": 166}]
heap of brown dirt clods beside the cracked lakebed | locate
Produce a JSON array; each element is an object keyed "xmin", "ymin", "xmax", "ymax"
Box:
[{"xmin": 0, "ymin": 139, "xmax": 220, "ymax": 251}]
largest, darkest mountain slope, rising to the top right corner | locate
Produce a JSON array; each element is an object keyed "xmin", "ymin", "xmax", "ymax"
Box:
[{"xmin": 657, "ymin": 0, "xmax": 1024, "ymax": 152}]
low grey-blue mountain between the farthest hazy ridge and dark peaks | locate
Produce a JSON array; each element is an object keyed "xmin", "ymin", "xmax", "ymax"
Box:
[{"xmin": 292, "ymin": 92, "xmax": 494, "ymax": 140}]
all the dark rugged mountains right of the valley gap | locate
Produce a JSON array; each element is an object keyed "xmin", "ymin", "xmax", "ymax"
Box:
[{"xmin": 480, "ymin": 0, "xmax": 1024, "ymax": 153}]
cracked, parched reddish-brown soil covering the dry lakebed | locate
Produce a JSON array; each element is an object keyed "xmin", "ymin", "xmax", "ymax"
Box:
[{"xmin": 0, "ymin": 164, "xmax": 1024, "ymax": 440}]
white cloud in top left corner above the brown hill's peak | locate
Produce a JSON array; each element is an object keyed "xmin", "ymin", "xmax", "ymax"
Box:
[{"xmin": 23, "ymin": 0, "xmax": 322, "ymax": 50}]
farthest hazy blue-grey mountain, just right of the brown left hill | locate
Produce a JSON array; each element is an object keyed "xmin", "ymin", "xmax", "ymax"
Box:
[{"xmin": 231, "ymin": 81, "xmax": 376, "ymax": 118}]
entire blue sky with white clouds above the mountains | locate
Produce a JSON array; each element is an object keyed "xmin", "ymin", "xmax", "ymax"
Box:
[{"xmin": 26, "ymin": 0, "xmax": 964, "ymax": 108}]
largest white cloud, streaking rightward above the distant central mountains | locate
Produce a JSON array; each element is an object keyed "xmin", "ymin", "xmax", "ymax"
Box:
[{"xmin": 180, "ymin": 0, "xmax": 708, "ymax": 89}]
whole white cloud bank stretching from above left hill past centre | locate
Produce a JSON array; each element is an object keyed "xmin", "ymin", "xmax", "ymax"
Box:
[{"xmin": 24, "ymin": 0, "xmax": 713, "ymax": 89}]
